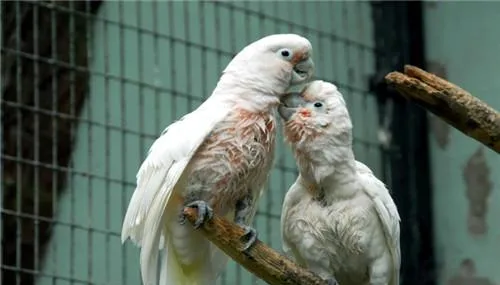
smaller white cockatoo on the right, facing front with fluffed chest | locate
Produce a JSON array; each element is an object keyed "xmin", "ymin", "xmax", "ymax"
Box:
[{"xmin": 278, "ymin": 80, "xmax": 401, "ymax": 285}]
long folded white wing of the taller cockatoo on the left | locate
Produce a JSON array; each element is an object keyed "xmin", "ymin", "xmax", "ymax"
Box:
[{"xmin": 122, "ymin": 99, "xmax": 230, "ymax": 285}]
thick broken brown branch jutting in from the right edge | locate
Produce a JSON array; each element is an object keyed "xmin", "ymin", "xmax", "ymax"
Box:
[{"xmin": 385, "ymin": 65, "xmax": 500, "ymax": 153}]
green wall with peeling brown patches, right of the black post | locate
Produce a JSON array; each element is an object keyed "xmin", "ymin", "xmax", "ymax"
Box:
[{"xmin": 425, "ymin": 1, "xmax": 500, "ymax": 285}]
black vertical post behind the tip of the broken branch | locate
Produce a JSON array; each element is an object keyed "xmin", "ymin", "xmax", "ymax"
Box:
[{"xmin": 398, "ymin": 2, "xmax": 436, "ymax": 284}]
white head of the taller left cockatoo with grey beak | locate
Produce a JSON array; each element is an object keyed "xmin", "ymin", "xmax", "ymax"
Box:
[{"xmin": 224, "ymin": 34, "xmax": 314, "ymax": 97}]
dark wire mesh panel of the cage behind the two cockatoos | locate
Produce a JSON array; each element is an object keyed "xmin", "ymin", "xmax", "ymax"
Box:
[{"xmin": 1, "ymin": 1, "xmax": 392, "ymax": 285}]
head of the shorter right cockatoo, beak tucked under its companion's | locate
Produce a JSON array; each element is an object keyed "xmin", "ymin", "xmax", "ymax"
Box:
[{"xmin": 278, "ymin": 80, "xmax": 352, "ymax": 156}]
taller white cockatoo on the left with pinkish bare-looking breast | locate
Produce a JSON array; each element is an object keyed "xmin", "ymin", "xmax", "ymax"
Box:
[{"xmin": 122, "ymin": 34, "xmax": 314, "ymax": 285}]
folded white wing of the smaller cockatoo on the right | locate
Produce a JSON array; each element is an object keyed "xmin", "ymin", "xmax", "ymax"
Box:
[{"xmin": 356, "ymin": 161, "xmax": 401, "ymax": 285}]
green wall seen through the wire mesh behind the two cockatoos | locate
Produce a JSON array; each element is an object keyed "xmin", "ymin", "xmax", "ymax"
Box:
[{"xmin": 38, "ymin": 1, "xmax": 380, "ymax": 285}]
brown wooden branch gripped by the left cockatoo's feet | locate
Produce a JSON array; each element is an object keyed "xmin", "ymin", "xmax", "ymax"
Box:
[{"xmin": 184, "ymin": 207, "xmax": 327, "ymax": 285}]
